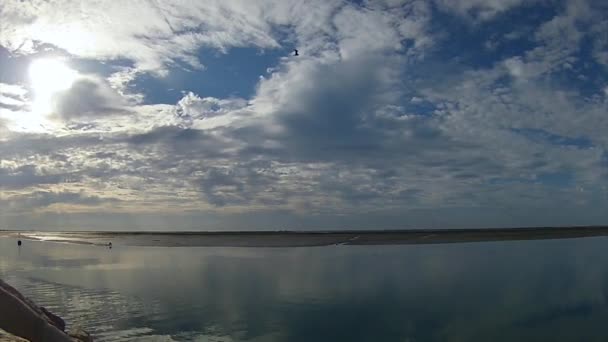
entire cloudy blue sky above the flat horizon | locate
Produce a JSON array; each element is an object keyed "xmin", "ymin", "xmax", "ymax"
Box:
[{"xmin": 0, "ymin": 0, "xmax": 608, "ymax": 230}]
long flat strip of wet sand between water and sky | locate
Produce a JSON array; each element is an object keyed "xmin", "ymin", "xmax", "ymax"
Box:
[{"xmin": 0, "ymin": 226, "xmax": 608, "ymax": 247}]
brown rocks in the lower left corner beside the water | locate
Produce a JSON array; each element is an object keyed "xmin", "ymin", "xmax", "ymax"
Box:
[{"xmin": 0, "ymin": 279, "xmax": 93, "ymax": 342}]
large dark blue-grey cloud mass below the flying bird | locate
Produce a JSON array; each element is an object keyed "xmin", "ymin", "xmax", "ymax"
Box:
[{"xmin": 276, "ymin": 59, "xmax": 391, "ymax": 157}]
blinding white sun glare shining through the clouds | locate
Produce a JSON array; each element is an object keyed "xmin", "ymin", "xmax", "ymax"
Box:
[{"xmin": 29, "ymin": 58, "xmax": 77, "ymax": 115}]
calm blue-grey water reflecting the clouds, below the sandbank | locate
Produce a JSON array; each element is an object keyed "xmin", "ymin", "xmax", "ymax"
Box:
[{"xmin": 0, "ymin": 238, "xmax": 608, "ymax": 341}]
